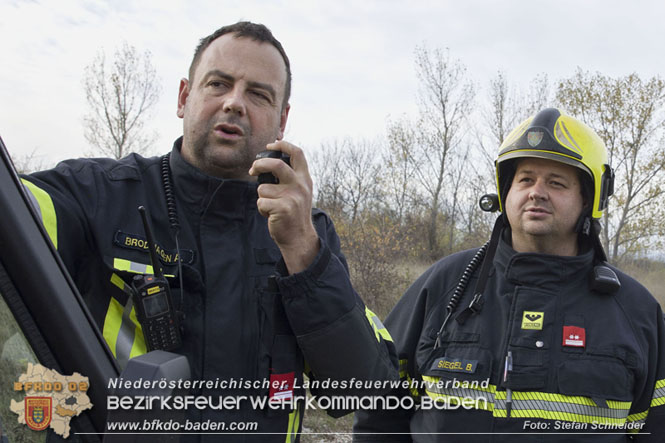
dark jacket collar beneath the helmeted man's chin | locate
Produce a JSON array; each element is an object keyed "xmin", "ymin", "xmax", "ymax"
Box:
[{"xmin": 494, "ymin": 235, "xmax": 594, "ymax": 290}]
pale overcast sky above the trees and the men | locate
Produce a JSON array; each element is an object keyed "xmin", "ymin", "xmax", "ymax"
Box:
[{"xmin": 0, "ymin": 0, "xmax": 665, "ymax": 165}]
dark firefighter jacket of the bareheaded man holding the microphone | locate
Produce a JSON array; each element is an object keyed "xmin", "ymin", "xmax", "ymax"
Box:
[{"xmin": 24, "ymin": 139, "xmax": 397, "ymax": 442}]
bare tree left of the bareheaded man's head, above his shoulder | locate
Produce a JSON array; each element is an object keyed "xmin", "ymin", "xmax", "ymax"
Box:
[{"xmin": 83, "ymin": 42, "xmax": 161, "ymax": 158}]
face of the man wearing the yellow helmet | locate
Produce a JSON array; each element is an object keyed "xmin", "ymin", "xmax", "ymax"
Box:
[{"xmin": 505, "ymin": 158, "xmax": 584, "ymax": 255}]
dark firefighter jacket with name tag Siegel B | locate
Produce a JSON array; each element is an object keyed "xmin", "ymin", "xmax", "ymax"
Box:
[{"xmin": 354, "ymin": 234, "xmax": 665, "ymax": 442}]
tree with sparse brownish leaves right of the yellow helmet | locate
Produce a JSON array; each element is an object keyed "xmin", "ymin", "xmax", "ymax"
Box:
[{"xmin": 557, "ymin": 70, "xmax": 665, "ymax": 263}]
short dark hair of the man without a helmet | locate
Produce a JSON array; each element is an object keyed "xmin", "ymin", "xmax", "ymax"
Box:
[{"xmin": 189, "ymin": 21, "xmax": 291, "ymax": 108}]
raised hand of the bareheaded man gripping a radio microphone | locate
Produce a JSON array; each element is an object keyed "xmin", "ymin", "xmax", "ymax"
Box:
[{"xmin": 249, "ymin": 140, "xmax": 319, "ymax": 273}]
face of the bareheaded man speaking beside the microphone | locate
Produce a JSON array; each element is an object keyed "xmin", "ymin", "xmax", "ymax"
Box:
[{"xmin": 178, "ymin": 34, "xmax": 289, "ymax": 179}]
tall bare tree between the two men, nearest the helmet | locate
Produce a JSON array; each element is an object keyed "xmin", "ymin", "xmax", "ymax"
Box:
[{"xmin": 414, "ymin": 48, "xmax": 475, "ymax": 258}]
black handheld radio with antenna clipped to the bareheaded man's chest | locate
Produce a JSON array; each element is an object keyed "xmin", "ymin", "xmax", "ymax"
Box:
[{"xmin": 132, "ymin": 206, "xmax": 182, "ymax": 351}]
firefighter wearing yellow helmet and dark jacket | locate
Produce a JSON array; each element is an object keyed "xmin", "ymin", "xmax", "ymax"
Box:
[{"xmin": 354, "ymin": 109, "xmax": 665, "ymax": 442}]
